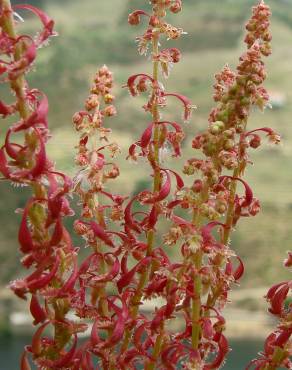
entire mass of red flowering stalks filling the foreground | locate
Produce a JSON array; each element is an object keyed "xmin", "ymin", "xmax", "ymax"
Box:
[{"xmin": 0, "ymin": 0, "xmax": 291, "ymax": 370}]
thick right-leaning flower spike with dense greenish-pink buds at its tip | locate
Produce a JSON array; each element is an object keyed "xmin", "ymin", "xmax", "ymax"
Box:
[{"xmin": 173, "ymin": 2, "xmax": 280, "ymax": 368}]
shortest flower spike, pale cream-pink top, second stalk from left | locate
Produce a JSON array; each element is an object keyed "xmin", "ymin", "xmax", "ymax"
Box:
[{"xmin": 72, "ymin": 66, "xmax": 134, "ymax": 369}]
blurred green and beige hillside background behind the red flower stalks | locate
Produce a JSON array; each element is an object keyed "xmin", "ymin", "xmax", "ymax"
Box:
[{"xmin": 0, "ymin": 0, "xmax": 292, "ymax": 370}]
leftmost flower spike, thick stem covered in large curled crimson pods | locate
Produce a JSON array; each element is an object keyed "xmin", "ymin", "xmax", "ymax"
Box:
[{"xmin": 0, "ymin": 1, "xmax": 83, "ymax": 370}]
